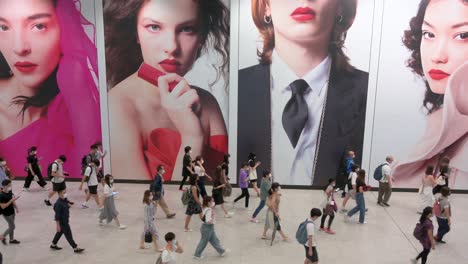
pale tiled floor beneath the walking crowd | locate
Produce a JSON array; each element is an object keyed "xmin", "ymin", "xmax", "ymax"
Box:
[{"xmin": 0, "ymin": 182, "xmax": 468, "ymax": 264}]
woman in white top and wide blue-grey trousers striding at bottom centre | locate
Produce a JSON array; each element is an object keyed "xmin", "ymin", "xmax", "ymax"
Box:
[{"xmin": 193, "ymin": 196, "xmax": 226, "ymax": 259}]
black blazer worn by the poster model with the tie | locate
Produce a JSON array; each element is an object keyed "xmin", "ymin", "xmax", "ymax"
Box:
[{"xmin": 237, "ymin": 64, "xmax": 368, "ymax": 186}]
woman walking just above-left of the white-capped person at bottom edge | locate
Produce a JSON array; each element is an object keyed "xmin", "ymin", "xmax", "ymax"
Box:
[{"xmin": 140, "ymin": 190, "xmax": 162, "ymax": 252}]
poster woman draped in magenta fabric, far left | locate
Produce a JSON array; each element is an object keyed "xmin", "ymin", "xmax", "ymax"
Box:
[{"xmin": 0, "ymin": 0, "xmax": 101, "ymax": 177}]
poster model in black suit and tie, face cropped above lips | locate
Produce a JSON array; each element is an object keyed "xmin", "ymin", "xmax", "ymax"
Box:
[{"xmin": 237, "ymin": 0, "xmax": 368, "ymax": 186}]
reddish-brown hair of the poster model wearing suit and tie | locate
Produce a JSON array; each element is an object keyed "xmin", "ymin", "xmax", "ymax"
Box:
[{"xmin": 252, "ymin": 0, "xmax": 357, "ymax": 71}]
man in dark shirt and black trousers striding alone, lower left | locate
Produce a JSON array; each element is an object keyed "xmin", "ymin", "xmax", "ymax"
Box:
[{"xmin": 50, "ymin": 188, "xmax": 84, "ymax": 253}]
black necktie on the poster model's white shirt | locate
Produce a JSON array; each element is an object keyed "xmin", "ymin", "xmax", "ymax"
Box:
[{"xmin": 282, "ymin": 79, "xmax": 309, "ymax": 148}]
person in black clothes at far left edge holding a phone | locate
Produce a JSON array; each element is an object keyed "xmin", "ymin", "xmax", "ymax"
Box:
[{"xmin": 0, "ymin": 180, "xmax": 20, "ymax": 245}]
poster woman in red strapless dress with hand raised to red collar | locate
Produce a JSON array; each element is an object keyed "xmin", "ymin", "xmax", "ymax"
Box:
[{"xmin": 104, "ymin": 0, "xmax": 229, "ymax": 180}]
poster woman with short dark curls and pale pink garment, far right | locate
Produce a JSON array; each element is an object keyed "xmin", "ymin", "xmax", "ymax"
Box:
[{"xmin": 394, "ymin": 0, "xmax": 468, "ymax": 189}]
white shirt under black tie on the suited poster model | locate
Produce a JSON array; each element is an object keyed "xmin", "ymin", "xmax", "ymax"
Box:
[{"xmin": 270, "ymin": 51, "xmax": 332, "ymax": 185}]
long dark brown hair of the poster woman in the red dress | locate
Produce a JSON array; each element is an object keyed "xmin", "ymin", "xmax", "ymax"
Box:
[{"xmin": 104, "ymin": 0, "xmax": 230, "ymax": 89}]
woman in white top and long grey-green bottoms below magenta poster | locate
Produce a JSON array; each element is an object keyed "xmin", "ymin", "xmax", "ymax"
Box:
[{"xmin": 99, "ymin": 174, "xmax": 127, "ymax": 229}]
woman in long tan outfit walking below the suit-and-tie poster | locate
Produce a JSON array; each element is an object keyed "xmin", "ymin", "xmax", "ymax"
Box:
[{"xmin": 262, "ymin": 182, "xmax": 289, "ymax": 241}]
